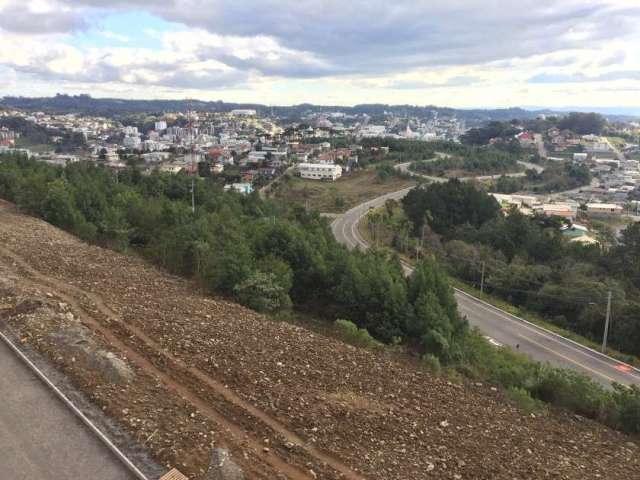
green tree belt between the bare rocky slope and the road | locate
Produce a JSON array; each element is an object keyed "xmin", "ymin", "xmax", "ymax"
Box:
[{"xmin": 0, "ymin": 156, "xmax": 466, "ymax": 360}]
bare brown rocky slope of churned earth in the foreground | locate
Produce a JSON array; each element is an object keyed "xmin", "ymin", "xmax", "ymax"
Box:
[{"xmin": 0, "ymin": 198, "xmax": 640, "ymax": 480}]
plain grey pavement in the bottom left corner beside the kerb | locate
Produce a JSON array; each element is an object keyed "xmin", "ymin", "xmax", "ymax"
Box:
[{"xmin": 0, "ymin": 341, "xmax": 134, "ymax": 480}]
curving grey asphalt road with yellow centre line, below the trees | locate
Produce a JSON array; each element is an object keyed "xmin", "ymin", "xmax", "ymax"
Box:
[{"xmin": 331, "ymin": 188, "xmax": 640, "ymax": 385}]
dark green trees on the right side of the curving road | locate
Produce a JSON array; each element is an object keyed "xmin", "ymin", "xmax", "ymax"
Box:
[{"xmin": 402, "ymin": 180, "xmax": 640, "ymax": 355}]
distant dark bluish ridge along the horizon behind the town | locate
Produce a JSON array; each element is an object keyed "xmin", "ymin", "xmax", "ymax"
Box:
[{"xmin": 0, "ymin": 94, "xmax": 640, "ymax": 126}]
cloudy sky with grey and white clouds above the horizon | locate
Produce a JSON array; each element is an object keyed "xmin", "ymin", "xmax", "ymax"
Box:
[{"xmin": 0, "ymin": 0, "xmax": 640, "ymax": 107}]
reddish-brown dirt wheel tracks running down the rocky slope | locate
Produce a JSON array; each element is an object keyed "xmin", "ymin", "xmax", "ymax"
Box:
[{"xmin": 0, "ymin": 246, "xmax": 366, "ymax": 480}]
